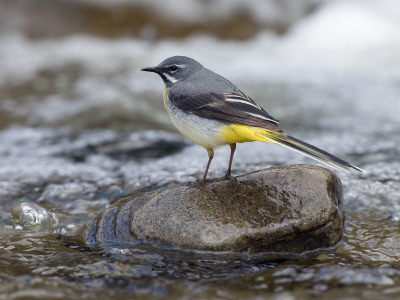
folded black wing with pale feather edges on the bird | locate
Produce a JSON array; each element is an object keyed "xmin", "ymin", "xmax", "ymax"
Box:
[{"xmin": 168, "ymin": 90, "xmax": 282, "ymax": 131}]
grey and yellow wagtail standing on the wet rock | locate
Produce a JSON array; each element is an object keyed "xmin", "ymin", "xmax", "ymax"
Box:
[{"xmin": 142, "ymin": 56, "xmax": 362, "ymax": 185}]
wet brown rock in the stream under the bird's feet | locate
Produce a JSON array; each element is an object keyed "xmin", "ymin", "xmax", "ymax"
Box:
[{"xmin": 79, "ymin": 165, "xmax": 344, "ymax": 255}]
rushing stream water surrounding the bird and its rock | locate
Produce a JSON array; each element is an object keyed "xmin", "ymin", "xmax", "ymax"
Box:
[{"xmin": 0, "ymin": 0, "xmax": 400, "ymax": 299}]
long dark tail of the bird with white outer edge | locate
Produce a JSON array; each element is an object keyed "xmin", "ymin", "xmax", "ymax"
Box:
[{"xmin": 264, "ymin": 130, "xmax": 363, "ymax": 172}]
